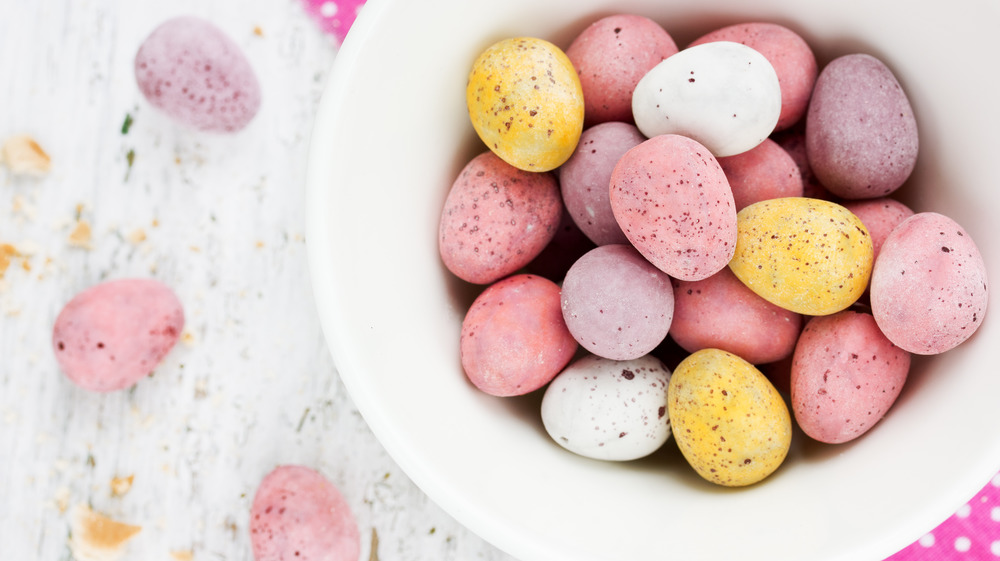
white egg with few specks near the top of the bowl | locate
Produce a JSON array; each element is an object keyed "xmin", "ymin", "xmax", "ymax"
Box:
[{"xmin": 632, "ymin": 41, "xmax": 781, "ymax": 157}]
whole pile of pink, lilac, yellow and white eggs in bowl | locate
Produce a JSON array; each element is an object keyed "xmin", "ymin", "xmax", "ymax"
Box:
[{"xmin": 438, "ymin": 14, "xmax": 989, "ymax": 486}]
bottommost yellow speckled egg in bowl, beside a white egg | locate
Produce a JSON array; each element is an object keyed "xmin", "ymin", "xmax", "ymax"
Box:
[{"xmin": 667, "ymin": 349, "xmax": 792, "ymax": 487}]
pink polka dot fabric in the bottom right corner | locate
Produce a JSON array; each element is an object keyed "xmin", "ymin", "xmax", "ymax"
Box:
[{"xmin": 887, "ymin": 473, "xmax": 1000, "ymax": 561}]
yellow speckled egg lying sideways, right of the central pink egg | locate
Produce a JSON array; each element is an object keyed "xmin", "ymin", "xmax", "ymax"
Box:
[{"xmin": 729, "ymin": 197, "xmax": 874, "ymax": 316}]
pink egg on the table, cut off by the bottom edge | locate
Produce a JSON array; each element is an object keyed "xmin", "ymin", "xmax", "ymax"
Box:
[{"xmin": 250, "ymin": 465, "xmax": 361, "ymax": 561}]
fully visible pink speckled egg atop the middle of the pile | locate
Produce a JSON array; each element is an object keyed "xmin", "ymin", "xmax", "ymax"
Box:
[{"xmin": 610, "ymin": 134, "xmax": 736, "ymax": 280}]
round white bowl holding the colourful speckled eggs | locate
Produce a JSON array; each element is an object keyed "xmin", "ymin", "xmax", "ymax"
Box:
[{"xmin": 307, "ymin": 0, "xmax": 1000, "ymax": 561}]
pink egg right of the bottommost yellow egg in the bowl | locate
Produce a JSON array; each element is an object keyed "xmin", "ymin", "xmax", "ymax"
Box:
[{"xmin": 791, "ymin": 310, "xmax": 910, "ymax": 444}]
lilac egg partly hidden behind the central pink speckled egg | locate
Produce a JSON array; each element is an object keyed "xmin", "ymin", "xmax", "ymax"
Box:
[{"xmin": 559, "ymin": 121, "xmax": 646, "ymax": 245}]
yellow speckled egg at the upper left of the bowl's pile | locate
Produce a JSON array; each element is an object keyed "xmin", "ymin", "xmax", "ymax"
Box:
[{"xmin": 465, "ymin": 37, "xmax": 583, "ymax": 172}]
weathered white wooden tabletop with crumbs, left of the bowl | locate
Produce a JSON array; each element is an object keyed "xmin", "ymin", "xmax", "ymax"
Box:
[{"xmin": 0, "ymin": 0, "xmax": 511, "ymax": 561}]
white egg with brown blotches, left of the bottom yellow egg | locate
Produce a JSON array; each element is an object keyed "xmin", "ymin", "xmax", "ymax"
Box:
[{"xmin": 542, "ymin": 355, "xmax": 670, "ymax": 461}]
